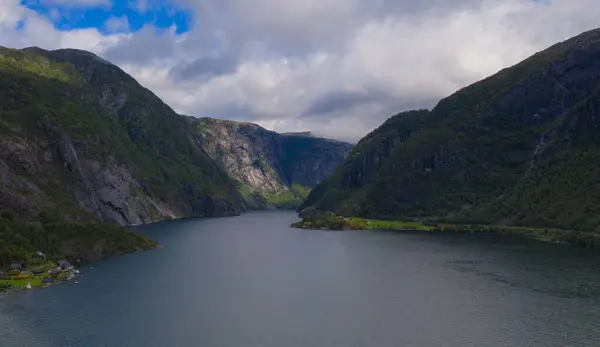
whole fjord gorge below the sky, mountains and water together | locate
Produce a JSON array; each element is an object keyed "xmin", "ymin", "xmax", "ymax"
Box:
[{"xmin": 0, "ymin": 23, "xmax": 600, "ymax": 347}]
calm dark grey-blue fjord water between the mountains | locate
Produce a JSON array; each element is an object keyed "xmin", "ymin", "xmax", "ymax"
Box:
[{"xmin": 0, "ymin": 212, "xmax": 600, "ymax": 347}]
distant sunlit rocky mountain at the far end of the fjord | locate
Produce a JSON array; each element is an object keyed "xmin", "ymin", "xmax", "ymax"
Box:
[{"xmin": 187, "ymin": 117, "xmax": 352, "ymax": 209}]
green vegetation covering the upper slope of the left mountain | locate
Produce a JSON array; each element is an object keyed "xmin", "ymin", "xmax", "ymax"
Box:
[{"xmin": 0, "ymin": 49, "xmax": 241, "ymax": 215}]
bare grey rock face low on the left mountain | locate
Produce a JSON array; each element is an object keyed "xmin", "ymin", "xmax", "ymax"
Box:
[{"xmin": 0, "ymin": 127, "xmax": 181, "ymax": 225}]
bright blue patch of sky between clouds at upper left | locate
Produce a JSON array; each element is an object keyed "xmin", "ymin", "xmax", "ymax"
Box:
[{"xmin": 21, "ymin": 0, "xmax": 192, "ymax": 34}]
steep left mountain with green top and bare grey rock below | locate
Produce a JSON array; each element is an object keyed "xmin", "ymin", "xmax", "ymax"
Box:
[{"xmin": 0, "ymin": 48, "xmax": 244, "ymax": 262}]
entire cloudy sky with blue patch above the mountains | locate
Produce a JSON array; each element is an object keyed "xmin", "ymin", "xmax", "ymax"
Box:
[{"xmin": 0, "ymin": 0, "xmax": 600, "ymax": 141}]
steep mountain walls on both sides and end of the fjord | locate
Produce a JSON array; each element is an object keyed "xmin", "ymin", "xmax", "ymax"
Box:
[{"xmin": 0, "ymin": 30, "xmax": 600, "ymax": 267}]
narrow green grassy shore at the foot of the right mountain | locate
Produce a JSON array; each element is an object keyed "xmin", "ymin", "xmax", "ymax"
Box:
[{"xmin": 292, "ymin": 214, "xmax": 600, "ymax": 248}]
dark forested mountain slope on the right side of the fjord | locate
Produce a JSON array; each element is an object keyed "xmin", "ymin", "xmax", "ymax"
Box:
[{"xmin": 300, "ymin": 30, "xmax": 600, "ymax": 231}]
